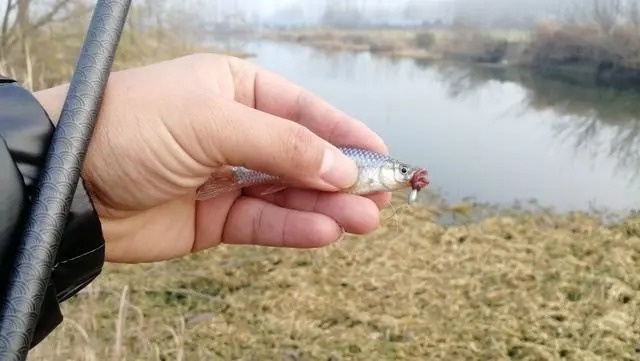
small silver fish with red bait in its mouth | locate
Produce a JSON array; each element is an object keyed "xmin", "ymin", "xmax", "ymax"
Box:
[{"xmin": 196, "ymin": 147, "xmax": 429, "ymax": 204}]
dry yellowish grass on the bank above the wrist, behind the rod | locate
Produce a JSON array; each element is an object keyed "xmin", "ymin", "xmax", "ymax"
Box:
[{"xmin": 0, "ymin": 2, "xmax": 252, "ymax": 90}]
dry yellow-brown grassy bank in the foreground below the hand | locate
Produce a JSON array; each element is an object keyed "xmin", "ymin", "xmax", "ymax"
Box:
[{"xmin": 31, "ymin": 190, "xmax": 640, "ymax": 361}]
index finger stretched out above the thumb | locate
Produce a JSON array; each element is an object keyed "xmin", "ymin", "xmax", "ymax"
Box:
[{"xmin": 230, "ymin": 60, "xmax": 388, "ymax": 154}]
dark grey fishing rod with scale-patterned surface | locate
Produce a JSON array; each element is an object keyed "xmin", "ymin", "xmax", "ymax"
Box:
[{"xmin": 0, "ymin": 0, "xmax": 131, "ymax": 361}]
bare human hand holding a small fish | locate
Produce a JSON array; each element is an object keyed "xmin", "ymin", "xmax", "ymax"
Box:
[{"xmin": 35, "ymin": 54, "xmax": 390, "ymax": 263}]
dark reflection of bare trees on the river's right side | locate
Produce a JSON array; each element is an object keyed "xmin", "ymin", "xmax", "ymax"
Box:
[{"xmin": 416, "ymin": 61, "xmax": 640, "ymax": 187}]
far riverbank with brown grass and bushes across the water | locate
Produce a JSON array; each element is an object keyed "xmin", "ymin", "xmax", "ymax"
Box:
[{"xmin": 263, "ymin": 22, "xmax": 640, "ymax": 88}]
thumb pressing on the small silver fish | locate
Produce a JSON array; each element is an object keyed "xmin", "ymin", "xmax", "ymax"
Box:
[{"xmin": 190, "ymin": 95, "xmax": 358, "ymax": 191}]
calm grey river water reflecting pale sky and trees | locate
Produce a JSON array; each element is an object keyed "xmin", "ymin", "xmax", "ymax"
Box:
[{"xmin": 238, "ymin": 42, "xmax": 640, "ymax": 211}]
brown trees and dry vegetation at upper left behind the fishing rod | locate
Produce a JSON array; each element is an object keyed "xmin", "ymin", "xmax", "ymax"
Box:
[{"xmin": 0, "ymin": 0, "xmax": 248, "ymax": 90}]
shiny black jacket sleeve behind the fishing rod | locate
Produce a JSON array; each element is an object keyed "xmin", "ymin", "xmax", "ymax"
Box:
[{"xmin": 0, "ymin": 76, "xmax": 104, "ymax": 347}]
